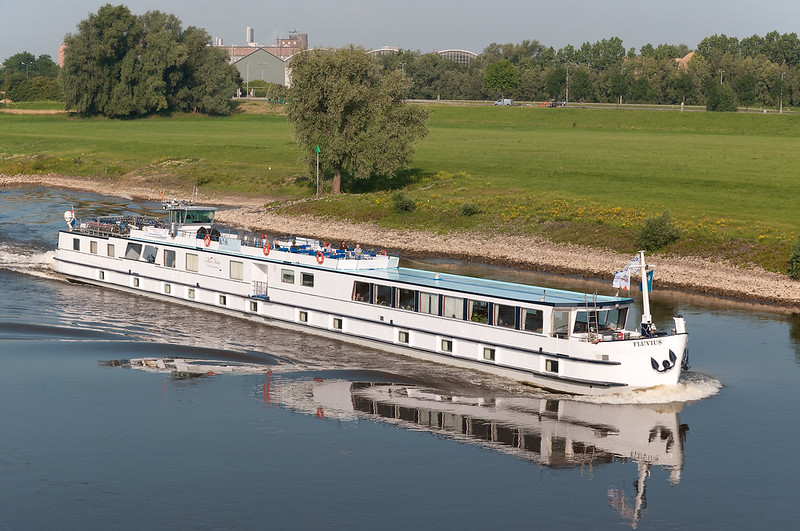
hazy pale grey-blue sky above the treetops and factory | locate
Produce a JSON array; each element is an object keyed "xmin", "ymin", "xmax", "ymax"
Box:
[{"xmin": 0, "ymin": 0, "xmax": 800, "ymax": 61}]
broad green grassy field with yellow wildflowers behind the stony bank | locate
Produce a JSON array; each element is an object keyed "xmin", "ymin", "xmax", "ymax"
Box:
[{"xmin": 0, "ymin": 105, "xmax": 800, "ymax": 271}]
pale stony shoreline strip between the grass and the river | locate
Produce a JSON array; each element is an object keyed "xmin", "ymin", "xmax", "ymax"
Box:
[{"xmin": 6, "ymin": 175, "xmax": 800, "ymax": 311}]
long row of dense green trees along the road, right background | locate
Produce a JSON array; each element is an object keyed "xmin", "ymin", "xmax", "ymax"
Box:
[{"xmin": 380, "ymin": 32, "xmax": 800, "ymax": 110}]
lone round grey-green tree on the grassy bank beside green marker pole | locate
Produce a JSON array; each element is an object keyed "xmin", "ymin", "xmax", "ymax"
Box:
[{"xmin": 287, "ymin": 45, "xmax": 428, "ymax": 193}]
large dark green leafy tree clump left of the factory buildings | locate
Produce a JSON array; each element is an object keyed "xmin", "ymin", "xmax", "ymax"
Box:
[{"xmin": 60, "ymin": 4, "xmax": 238, "ymax": 116}]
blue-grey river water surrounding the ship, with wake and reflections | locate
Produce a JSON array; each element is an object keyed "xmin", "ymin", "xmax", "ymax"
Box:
[{"xmin": 0, "ymin": 188, "xmax": 800, "ymax": 530}]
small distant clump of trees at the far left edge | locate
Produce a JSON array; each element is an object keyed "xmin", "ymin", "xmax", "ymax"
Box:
[{"xmin": 0, "ymin": 52, "xmax": 62, "ymax": 101}]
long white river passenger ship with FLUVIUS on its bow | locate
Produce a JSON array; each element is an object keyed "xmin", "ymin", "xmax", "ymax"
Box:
[{"xmin": 55, "ymin": 202, "xmax": 688, "ymax": 394}]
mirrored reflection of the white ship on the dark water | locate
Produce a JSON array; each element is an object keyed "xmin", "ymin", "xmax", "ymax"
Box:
[{"xmin": 112, "ymin": 358, "xmax": 689, "ymax": 528}]
